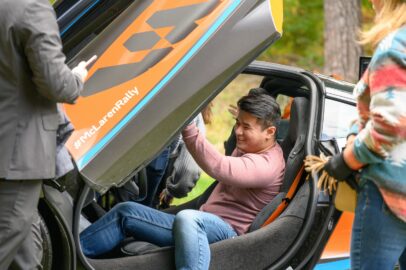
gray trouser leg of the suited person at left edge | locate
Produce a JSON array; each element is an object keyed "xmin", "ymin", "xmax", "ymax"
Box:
[{"xmin": 0, "ymin": 180, "xmax": 42, "ymax": 269}]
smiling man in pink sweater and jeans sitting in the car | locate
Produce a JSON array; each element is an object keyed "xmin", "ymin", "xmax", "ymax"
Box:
[{"xmin": 80, "ymin": 91, "xmax": 285, "ymax": 269}]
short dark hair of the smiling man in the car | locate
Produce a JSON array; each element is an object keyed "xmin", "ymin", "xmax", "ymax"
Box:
[{"xmin": 237, "ymin": 88, "xmax": 281, "ymax": 129}]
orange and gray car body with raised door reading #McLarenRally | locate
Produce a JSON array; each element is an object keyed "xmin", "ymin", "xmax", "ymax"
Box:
[{"xmin": 35, "ymin": 0, "xmax": 356, "ymax": 269}]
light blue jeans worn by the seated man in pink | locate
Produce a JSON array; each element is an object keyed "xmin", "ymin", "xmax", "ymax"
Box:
[{"xmin": 80, "ymin": 202, "xmax": 237, "ymax": 270}]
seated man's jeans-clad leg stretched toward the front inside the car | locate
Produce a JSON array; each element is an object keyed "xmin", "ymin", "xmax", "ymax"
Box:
[{"xmin": 80, "ymin": 202, "xmax": 175, "ymax": 257}]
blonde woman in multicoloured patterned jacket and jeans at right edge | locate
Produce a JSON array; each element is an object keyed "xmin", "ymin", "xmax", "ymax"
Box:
[{"xmin": 325, "ymin": 0, "xmax": 406, "ymax": 270}]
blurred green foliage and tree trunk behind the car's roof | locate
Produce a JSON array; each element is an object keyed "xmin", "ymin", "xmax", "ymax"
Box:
[{"xmin": 259, "ymin": 0, "xmax": 374, "ymax": 82}]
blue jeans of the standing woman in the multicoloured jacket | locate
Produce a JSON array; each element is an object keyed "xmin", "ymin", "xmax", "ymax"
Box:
[{"xmin": 351, "ymin": 180, "xmax": 406, "ymax": 270}]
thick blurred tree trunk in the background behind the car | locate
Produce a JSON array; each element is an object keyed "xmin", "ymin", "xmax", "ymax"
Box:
[{"xmin": 324, "ymin": 0, "xmax": 362, "ymax": 82}]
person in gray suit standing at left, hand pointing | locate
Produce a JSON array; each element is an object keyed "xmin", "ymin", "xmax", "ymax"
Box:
[{"xmin": 0, "ymin": 0, "xmax": 87, "ymax": 269}]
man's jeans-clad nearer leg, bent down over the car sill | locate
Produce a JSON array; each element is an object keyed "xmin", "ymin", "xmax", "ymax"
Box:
[{"xmin": 173, "ymin": 210, "xmax": 237, "ymax": 270}]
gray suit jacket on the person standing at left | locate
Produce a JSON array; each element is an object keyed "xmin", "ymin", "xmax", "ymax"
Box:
[{"xmin": 0, "ymin": 0, "xmax": 83, "ymax": 179}]
